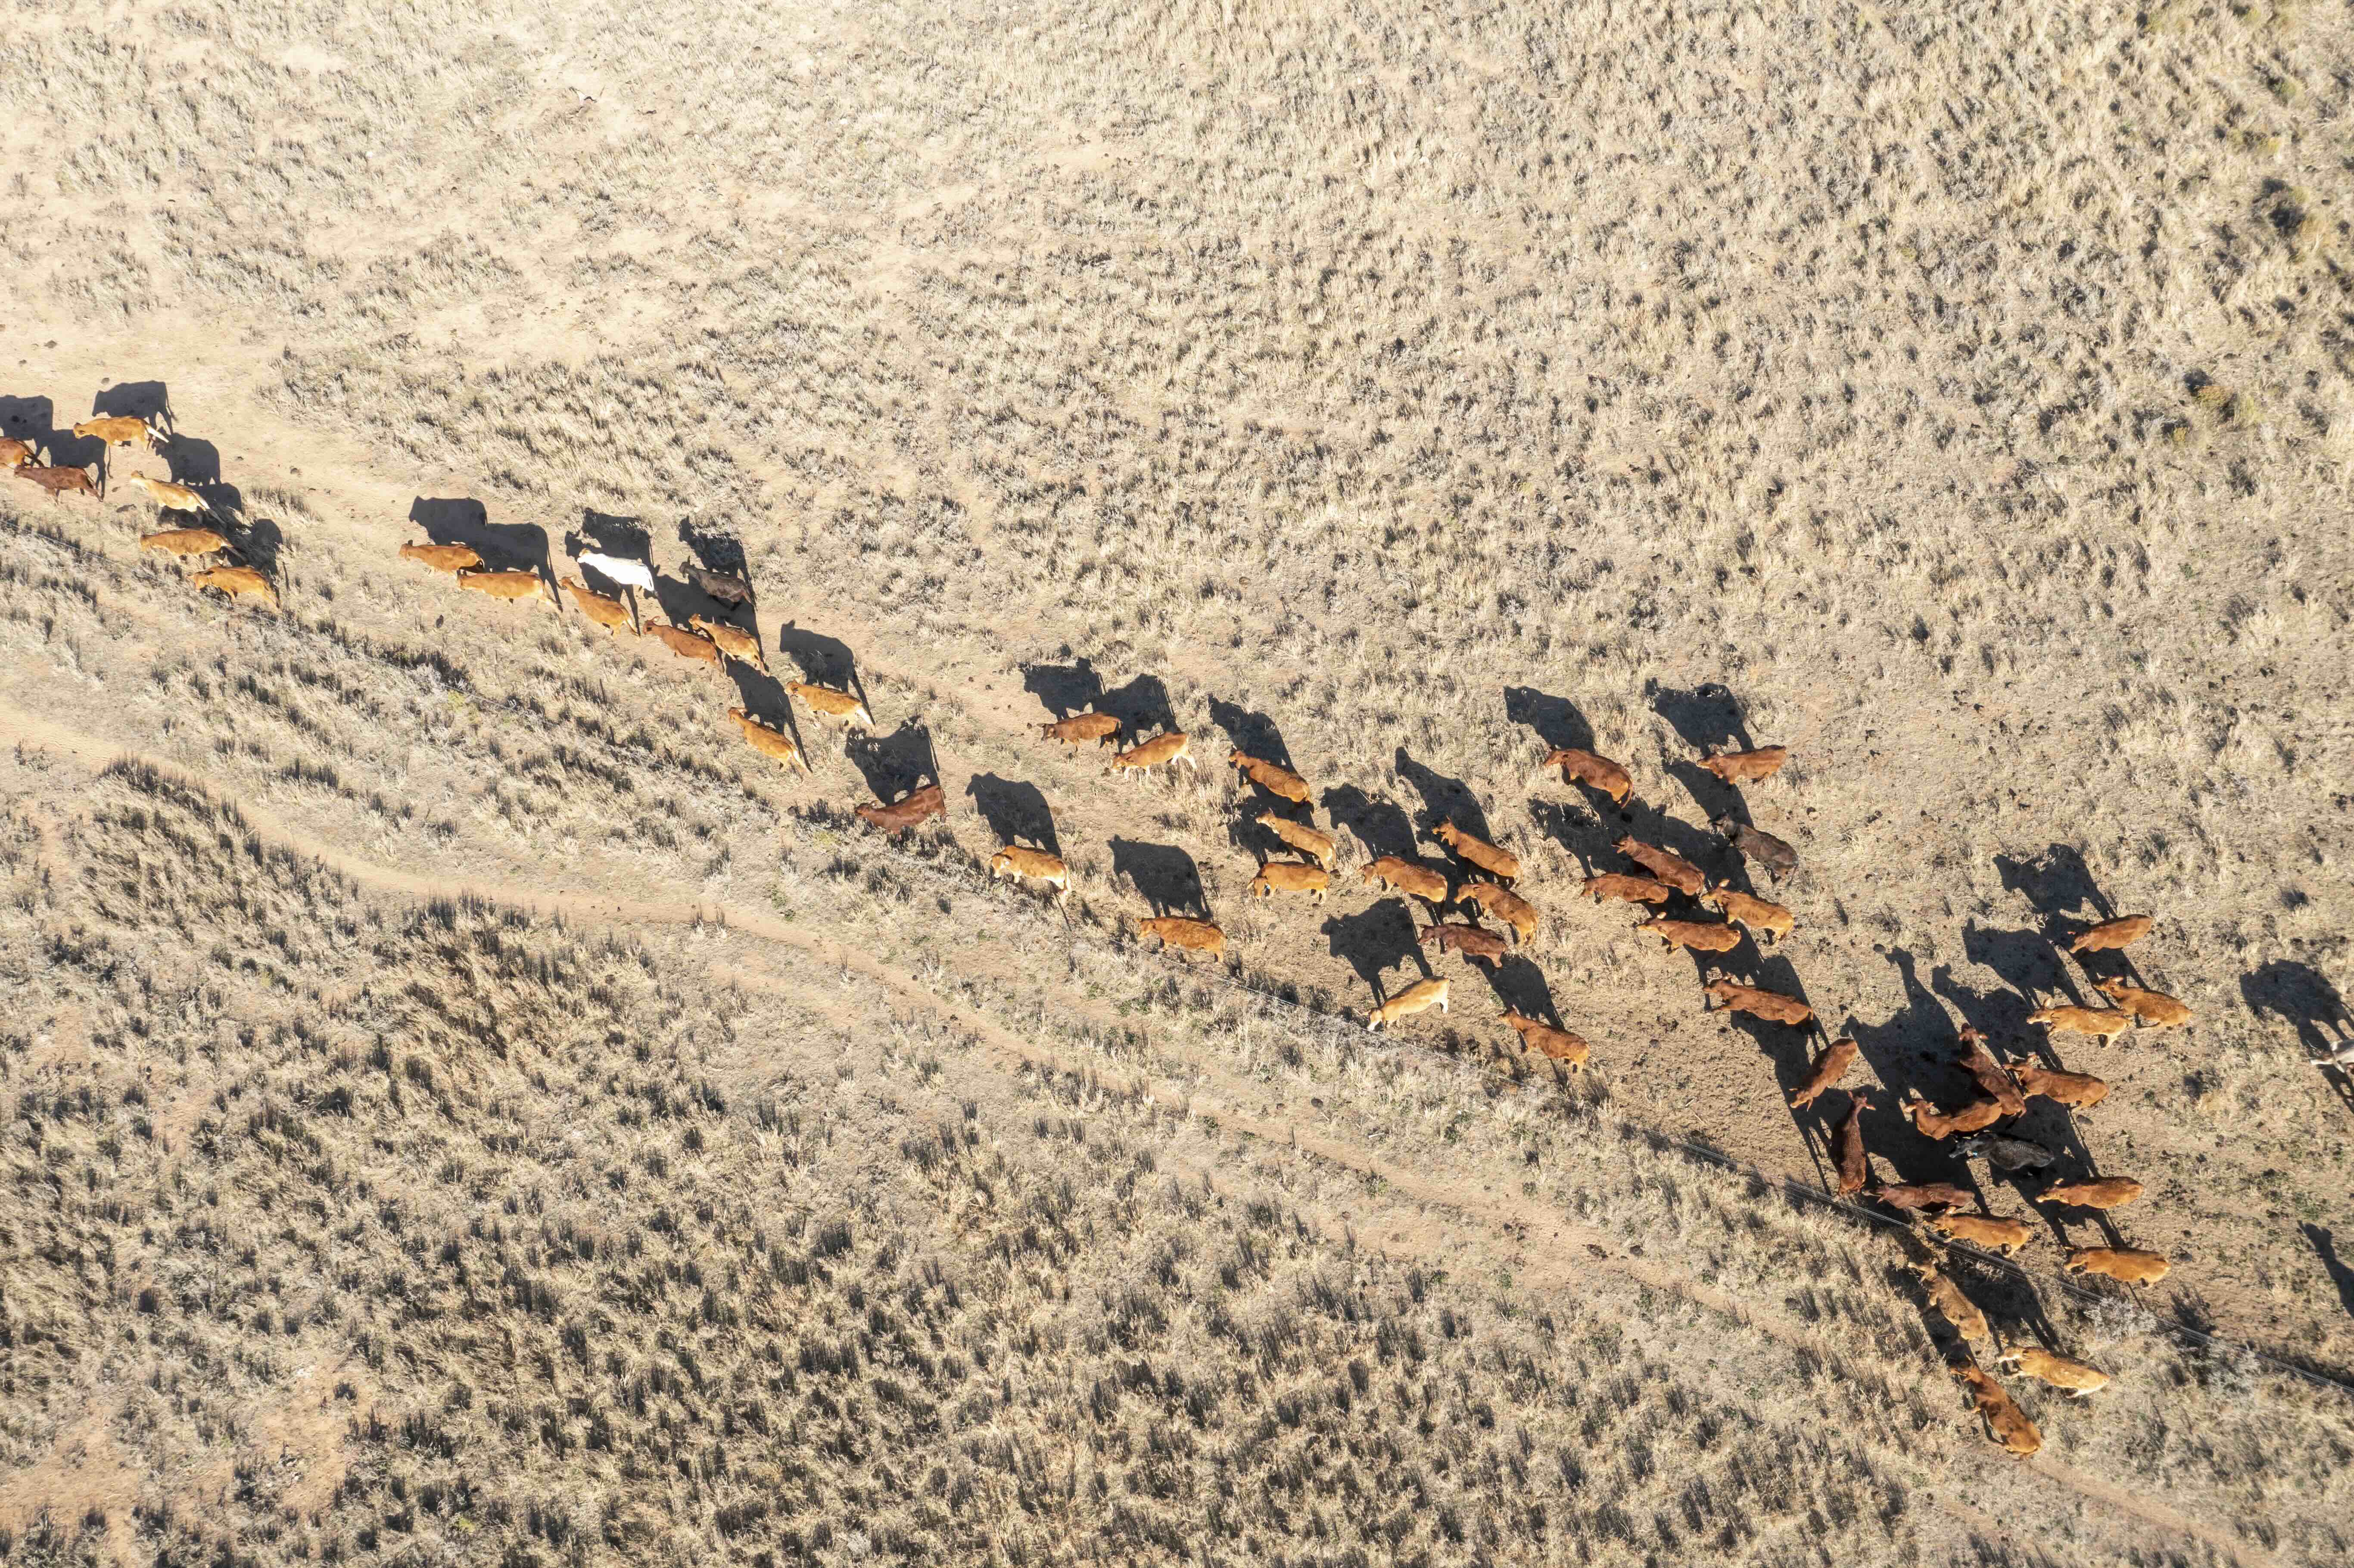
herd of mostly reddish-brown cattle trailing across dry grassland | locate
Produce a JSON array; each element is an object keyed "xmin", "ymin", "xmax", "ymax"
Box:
[{"xmin": 0, "ymin": 381, "xmax": 2192, "ymax": 1457}]
